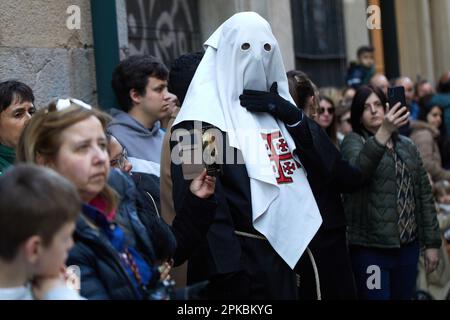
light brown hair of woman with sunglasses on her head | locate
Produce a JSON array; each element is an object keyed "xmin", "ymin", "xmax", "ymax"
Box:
[{"xmin": 16, "ymin": 101, "xmax": 118, "ymax": 211}]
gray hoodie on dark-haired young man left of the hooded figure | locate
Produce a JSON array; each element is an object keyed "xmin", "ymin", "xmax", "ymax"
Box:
[{"xmin": 107, "ymin": 109, "xmax": 164, "ymax": 170}]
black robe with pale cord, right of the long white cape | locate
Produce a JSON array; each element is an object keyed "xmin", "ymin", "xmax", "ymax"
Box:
[{"xmin": 292, "ymin": 119, "xmax": 362, "ymax": 300}]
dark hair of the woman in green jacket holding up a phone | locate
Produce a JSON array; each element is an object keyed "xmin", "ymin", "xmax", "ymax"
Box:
[{"xmin": 350, "ymin": 85, "xmax": 387, "ymax": 135}]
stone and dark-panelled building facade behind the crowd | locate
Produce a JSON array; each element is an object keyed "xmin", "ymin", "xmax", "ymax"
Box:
[{"xmin": 0, "ymin": 0, "xmax": 450, "ymax": 109}]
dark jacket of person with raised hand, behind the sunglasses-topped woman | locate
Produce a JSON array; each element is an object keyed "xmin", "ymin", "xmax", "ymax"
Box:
[{"xmin": 108, "ymin": 170, "xmax": 216, "ymax": 266}]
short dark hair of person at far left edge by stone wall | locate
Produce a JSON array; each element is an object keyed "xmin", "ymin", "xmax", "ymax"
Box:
[{"xmin": 0, "ymin": 80, "xmax": 34, "ymax": 112}]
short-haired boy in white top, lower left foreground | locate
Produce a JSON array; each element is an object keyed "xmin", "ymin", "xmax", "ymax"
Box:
[{"xmin": 0, "ymin": 164, "xmax": 83, "ymax": 300}]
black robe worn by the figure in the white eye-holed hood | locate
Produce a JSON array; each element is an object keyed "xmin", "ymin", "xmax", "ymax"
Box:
[{"xmin": 171, "ymin": 121, "xmax": 320, "ymax": 299}]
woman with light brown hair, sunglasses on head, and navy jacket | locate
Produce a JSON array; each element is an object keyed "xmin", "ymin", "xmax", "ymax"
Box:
[{"xmin": 17, "ymin": 99, "xmax": 214, "ymax": 299}]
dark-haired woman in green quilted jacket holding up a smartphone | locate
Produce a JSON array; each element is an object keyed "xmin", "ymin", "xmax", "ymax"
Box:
[{"xmin": 341, "ymin": 86, "xmax": 441, "ymax": 300}]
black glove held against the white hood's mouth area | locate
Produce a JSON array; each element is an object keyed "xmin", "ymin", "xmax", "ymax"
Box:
[{"xmin": 239, "ymin": 82, "xmax": 303, "ymax": 125}]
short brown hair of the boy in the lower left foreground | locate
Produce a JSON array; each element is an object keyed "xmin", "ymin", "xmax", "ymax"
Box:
[{"xmin": 0, "ymin": 164, "xmax": 81, "ymax": 261}]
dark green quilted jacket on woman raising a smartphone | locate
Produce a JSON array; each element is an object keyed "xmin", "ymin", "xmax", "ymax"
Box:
[{"xmin": 341, "ymin": 133, "xmax": 441, "ymax": 248}]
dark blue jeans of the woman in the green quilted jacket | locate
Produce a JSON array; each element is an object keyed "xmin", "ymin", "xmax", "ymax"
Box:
[{"xmin": 349, "ymin": 241, "xmax": 420, "ymax": 300}]
